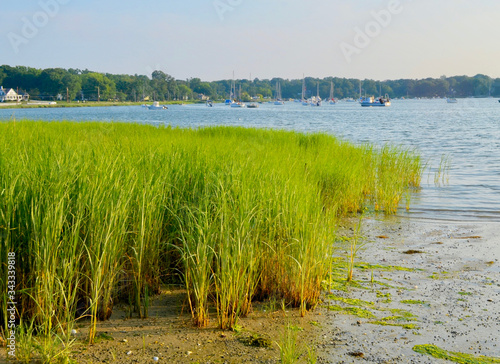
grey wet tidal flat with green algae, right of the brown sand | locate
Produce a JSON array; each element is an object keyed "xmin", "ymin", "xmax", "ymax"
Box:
[{"xmin": 321, "ymin": 218, "xmax": 500, "ymax": 363}]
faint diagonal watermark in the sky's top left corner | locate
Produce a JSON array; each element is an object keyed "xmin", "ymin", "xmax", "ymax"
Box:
[{"xmin": 7, "ymin": 0, "xmax": 71, "ymax": 54}]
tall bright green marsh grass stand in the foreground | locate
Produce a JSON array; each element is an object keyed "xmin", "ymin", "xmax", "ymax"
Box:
[{"xmin": 0, "ymin": 120, "xmax": 424, "ymax": 362}]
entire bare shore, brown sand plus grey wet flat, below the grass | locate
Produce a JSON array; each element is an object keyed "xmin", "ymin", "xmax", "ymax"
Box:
[{"xmin": 63, "ymin": 218, "xmax": 500, "ymax": 363}]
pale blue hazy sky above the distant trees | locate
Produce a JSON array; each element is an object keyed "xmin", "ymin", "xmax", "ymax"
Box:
[{"xmin": 0, "ymin": 0, "xmax": 500, "ymax": 81}]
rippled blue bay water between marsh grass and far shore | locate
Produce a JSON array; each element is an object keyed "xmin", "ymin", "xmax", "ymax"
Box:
[{"xmin": 0, "ymin": 99, "xmax": 500, "ymax": 221}]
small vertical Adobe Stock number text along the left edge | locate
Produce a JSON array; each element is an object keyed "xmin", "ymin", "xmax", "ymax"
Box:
[{"xmin": 5, "ymin": 252, "xmax": 16, "ymax": 359}]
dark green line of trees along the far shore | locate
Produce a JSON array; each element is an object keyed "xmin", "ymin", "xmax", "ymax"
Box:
[{"xmin": 0, "ymin": 65, "xmax": 500, "ymax": 101}]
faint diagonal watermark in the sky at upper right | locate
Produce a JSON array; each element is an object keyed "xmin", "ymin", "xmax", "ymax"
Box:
[{"xmin": 340, "ymin": 0, "xmax": 404, "ymax": 63}]
